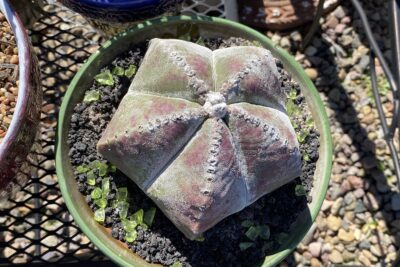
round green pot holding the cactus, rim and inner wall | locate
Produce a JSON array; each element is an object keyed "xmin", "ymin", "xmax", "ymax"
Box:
[{"xmin": 56, "ymin": 16, "xmax": 332, "ymax": 266}]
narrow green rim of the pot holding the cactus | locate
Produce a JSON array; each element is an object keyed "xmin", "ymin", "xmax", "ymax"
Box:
[{"xmin": 56, "ymin": 16, "xmax": 332, "ymax": 266}]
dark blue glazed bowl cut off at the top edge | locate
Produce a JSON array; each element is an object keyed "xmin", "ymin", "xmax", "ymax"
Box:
[{"xmin": 61, "ymin": 0, "xmax": 183, "ymax": 23}]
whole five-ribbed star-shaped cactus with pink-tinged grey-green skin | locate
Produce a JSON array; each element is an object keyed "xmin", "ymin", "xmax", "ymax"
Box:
[{"xmin": 97, "ymin": 39, "xmax": 301, "ymax": 239}]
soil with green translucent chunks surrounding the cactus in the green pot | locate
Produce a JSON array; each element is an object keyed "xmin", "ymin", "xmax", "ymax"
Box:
[{"xmin": 68, "ymin": 38, "xmax": 319, "ymax": 266}]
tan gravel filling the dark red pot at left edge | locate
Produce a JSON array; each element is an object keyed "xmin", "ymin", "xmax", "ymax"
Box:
[{"xmin": 0, "ymin": 12, "xmax": 18, "ymax": 143}]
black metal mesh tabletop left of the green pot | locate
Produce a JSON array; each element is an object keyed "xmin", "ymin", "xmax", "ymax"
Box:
[{"xmin": 0, "ymin": 0, "xmax": 226, "ymax": 266}]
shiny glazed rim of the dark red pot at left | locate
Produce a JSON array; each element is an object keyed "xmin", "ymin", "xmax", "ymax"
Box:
[{"xmin": 0, "ymin": 0, "xmax": 32, "ymax": 172}]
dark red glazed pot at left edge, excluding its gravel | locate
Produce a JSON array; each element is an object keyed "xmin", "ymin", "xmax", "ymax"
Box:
[{"xmin": 0, "ymin": 0, "xmax": 42, "ymax": 197}]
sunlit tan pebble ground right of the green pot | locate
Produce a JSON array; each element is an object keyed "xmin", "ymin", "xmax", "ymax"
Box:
[{"xmin": 267, "ymin": 0, "xmax": 400, "ymax": 267}]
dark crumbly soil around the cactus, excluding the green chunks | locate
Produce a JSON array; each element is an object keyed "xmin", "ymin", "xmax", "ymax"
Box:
[{"xmin": 68, "ymin": 38, "xmax": 319, "ymax": 266}]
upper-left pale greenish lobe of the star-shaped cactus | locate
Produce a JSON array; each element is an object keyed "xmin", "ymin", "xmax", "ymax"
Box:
[{"xmin": 130, "ymin": 39, "xmax": 213, "ymax": 101}]
